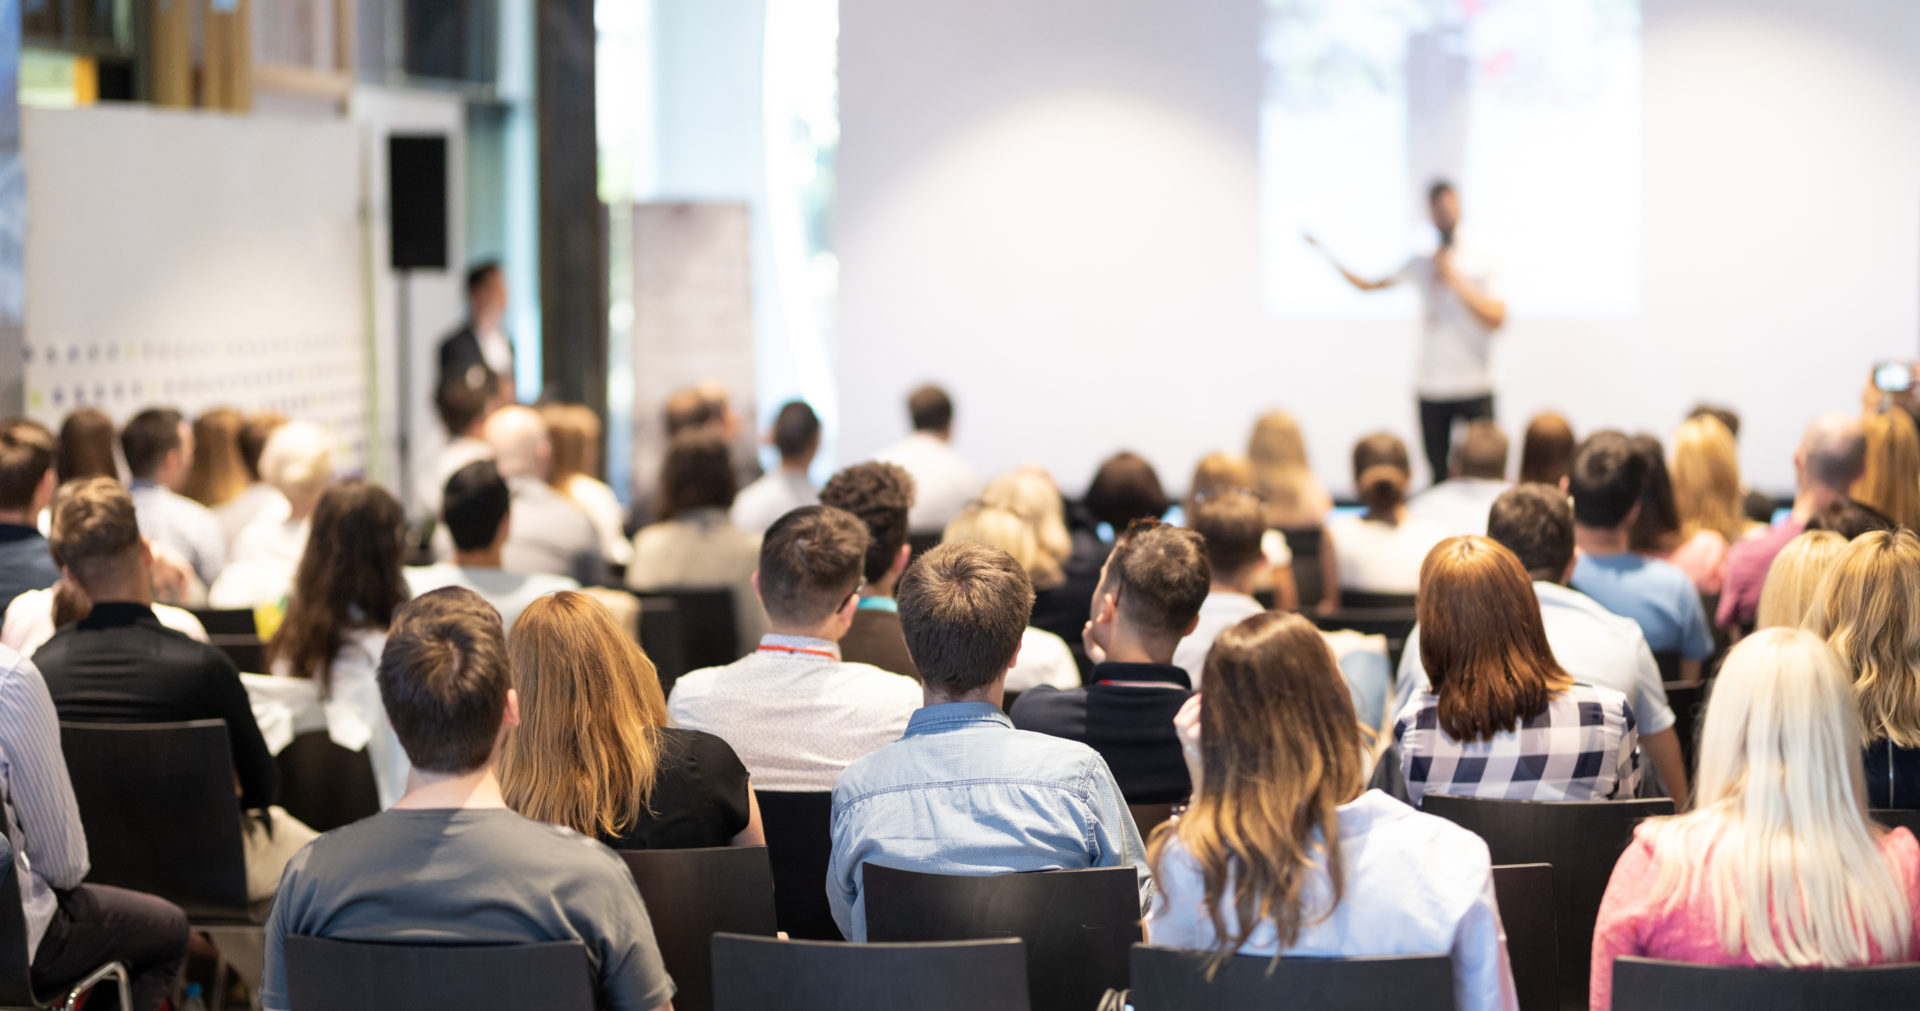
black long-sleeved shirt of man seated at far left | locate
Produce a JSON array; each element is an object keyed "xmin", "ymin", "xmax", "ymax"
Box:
[{"xmin": 33, "ymin": 602, "xmax": 278, "ymax": 808}]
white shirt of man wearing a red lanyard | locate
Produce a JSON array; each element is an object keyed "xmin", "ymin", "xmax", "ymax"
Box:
[{"xmin": 666, "ymin": 635, "xmax": 920, "ymax": 792}]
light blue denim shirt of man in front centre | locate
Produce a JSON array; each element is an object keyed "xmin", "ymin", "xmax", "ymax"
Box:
[{"xmin": 826, "ymin": 702, "xmax": 1154, "ymax": 942}]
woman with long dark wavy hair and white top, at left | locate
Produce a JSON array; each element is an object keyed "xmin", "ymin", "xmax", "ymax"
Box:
[{"xmin": 266, "ymin": 480, "xmax": 409, "ymax": 808}]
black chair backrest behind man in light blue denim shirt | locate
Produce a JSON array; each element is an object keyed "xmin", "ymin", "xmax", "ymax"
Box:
[{"xmin": 860, "ymin": 863, "xmax": 1140, "ymax": 1011}]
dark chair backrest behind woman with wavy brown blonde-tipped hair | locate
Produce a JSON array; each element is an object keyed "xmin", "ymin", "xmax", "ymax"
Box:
[{"xmin": 1129, "ymin": 944, "xmax": 1453, "ymax": 1011}]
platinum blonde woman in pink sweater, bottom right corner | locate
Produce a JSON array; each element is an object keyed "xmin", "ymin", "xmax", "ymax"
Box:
[{"xmin": 1590, "ymin": 629, "xmax": 1920, "ymax": 1011}]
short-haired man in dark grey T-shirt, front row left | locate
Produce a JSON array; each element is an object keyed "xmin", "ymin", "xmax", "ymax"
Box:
[{"xmin": 259, "ymin": 587, "xmax": 674, "ymax": 1011}]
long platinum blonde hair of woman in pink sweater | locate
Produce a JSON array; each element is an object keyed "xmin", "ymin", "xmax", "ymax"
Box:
[{"xmin": 1642, "ymin": 629, "xmax": 1914, "ymax": 967}]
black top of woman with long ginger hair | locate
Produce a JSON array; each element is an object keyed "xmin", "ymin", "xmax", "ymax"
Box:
[{"xmin": 601, "ymin": 727, "xmax": 751, "ymax": 850}]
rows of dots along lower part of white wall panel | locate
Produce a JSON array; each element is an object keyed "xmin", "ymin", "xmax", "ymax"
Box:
[{"xmin": 21, "ymin": 334, "xmax": 369, "ymax": 474}]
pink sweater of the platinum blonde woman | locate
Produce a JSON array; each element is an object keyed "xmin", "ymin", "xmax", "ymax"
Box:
[{"xmin": 1588, "ymin": 829, "xmax": 1920, "ymax": 1011}]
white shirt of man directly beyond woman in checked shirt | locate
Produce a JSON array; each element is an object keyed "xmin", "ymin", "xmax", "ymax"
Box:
[{"xmin": 1394, "ymin": 579, "xmax": 1674, "ymax": 737}]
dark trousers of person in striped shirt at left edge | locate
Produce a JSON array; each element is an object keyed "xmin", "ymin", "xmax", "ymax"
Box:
[{"xmin": 33, "ymin": 884, "xmax": 188, "ymax": 1011}]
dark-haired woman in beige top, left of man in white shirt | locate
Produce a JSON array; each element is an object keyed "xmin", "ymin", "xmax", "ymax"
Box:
[{"xmin": 626, "ymin": 430, "xmax": 768, "ymax": 654}]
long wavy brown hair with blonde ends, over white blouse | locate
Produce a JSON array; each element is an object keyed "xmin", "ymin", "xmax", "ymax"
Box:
[{"xmin": 1146, "ymin": 610, "xmax": 1367, "ymax": 973}]
